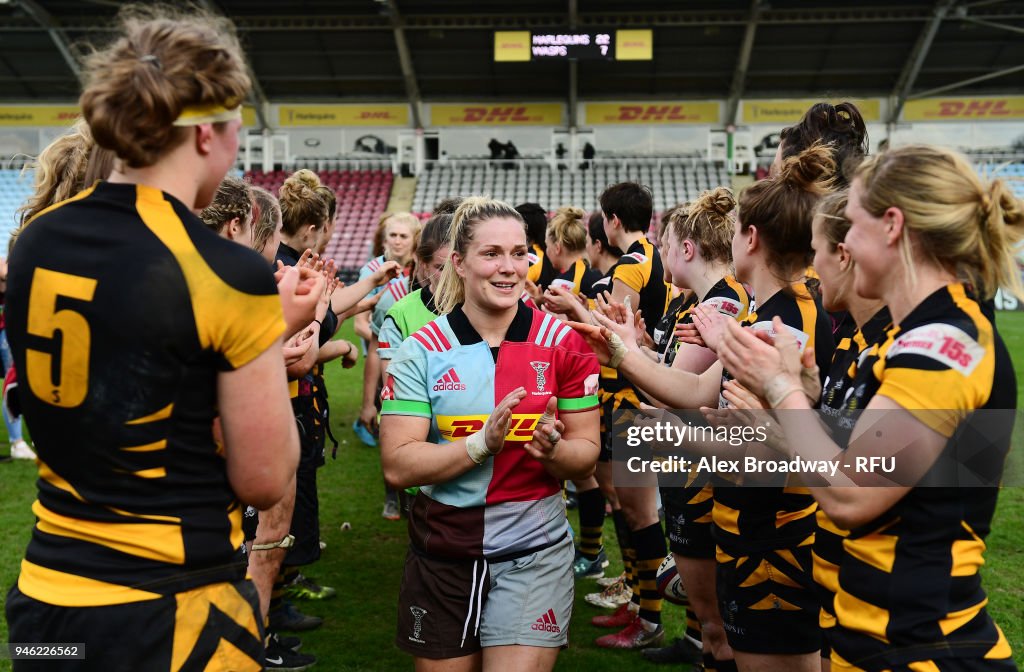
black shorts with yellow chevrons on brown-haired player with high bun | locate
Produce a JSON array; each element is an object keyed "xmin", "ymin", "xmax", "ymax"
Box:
[{"xmin": 715, "ymin": 543, "xmax": 821, "ymax": 656}]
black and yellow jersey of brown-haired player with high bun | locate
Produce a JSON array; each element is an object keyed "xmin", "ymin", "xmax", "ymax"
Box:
[{"xmin": 712, "ymin": 283, "xmax": 835, "ymax": 557}]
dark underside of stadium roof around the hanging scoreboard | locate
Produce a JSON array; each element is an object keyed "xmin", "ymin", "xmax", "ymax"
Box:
[{"xmin": 0, "ymin": 0, "xmax": 1024, "ymax": 126}]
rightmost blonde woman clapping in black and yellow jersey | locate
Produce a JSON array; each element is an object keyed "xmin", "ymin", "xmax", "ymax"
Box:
[{"xmin": 720, "ymin": 145, "xmax": 1024, "ymax": 672}]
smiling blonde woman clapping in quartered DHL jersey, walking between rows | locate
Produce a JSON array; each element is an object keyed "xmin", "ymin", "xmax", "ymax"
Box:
[{"xmin": 381, "ymin": 198, "xmax": 598, "ymax": 670}]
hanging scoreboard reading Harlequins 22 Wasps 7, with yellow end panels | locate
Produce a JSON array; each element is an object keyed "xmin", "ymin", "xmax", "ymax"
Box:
[{"xmin": 495, "ymin": 30, "xmax": 653, "ymax": 62}]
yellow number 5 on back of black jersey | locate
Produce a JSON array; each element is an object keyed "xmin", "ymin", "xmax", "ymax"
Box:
[{"xmin": 25, "ymin": 268, "xmax": 96, "ymax": 409}]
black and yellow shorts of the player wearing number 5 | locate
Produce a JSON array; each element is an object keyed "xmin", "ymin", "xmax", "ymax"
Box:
[{"xmin": 6, "ymin": 581, "xmax": 264, "ymax": 672}]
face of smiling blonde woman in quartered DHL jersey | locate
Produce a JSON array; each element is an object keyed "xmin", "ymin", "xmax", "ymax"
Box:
[{"xmin": 452, "ymin": 217, "xmax": 529, "ymax": 312}]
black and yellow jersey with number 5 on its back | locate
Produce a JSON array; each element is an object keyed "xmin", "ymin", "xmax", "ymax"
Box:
[{"xmin": 7, "ymin": 182, "xmax": 285, "ymax": 606}]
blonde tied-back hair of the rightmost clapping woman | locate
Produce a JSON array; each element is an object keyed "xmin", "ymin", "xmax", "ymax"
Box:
[{"xmin": 853, "ymin": 144, "xmax": 1024, "ymax": 299}]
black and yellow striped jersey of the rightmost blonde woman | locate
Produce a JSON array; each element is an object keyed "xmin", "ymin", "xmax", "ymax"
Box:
[{"xmin": 829, "ymin": 283, "xmax": 1017, "ymax": 670}]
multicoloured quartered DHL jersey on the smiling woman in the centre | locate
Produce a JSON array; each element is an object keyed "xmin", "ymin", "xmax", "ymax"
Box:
[{"xmin": 381, "ymin": 303, "xmax": 598, "ymax": 558}]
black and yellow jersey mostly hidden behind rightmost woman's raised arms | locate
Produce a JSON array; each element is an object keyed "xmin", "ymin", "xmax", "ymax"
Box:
[{"xmin": 813, "ymin": 307, "xmax": 892, "ymax": 628}]
